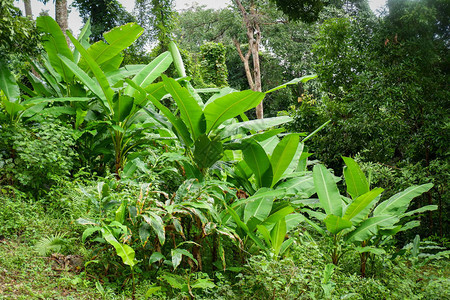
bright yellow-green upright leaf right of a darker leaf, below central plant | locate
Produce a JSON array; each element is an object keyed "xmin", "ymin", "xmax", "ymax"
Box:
[{"xmin": 270, "ymin": 133, "xmax": 299, "ymax": 187}]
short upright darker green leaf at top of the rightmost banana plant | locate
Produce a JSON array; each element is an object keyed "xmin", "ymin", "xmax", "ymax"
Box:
[{"xmin": 342, "ymin": 157, "xmax": 369, "ymax": 199}]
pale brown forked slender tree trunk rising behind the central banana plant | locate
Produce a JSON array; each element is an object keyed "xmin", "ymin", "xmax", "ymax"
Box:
[{"xmin": 233, "ymin": 0, "xmax": 264, "ymax": 119}]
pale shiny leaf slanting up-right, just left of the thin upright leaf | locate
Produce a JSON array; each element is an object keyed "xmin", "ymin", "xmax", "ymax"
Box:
[{"xmin": 124, "ymin": 52, "xmax": 172, "ymax": 96}]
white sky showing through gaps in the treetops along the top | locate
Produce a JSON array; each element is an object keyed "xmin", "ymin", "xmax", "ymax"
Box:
[{"xmin": 14, "ymin": 0, "xmax": 386, "ymax": 36}]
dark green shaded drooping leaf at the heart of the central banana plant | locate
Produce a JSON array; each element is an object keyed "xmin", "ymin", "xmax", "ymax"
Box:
[{"xmin": 193, "ymin": 134, "xmax": 223, "ymax": 170}]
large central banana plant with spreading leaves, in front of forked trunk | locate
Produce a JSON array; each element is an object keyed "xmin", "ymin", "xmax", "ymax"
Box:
[{"xmin": 142, "ymin": 42, "xmax": 314, "ymax": 179}]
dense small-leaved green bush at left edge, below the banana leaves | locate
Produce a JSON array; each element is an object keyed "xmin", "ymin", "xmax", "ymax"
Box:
[{"xmin": 0, "ymin": 120, "xmax": 77, "ymax": 194}]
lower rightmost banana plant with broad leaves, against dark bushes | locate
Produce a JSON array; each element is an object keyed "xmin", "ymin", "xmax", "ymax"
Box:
[{"xmin": 313, "ymin": 157, "xmax": 436, "ymax": 275}]
